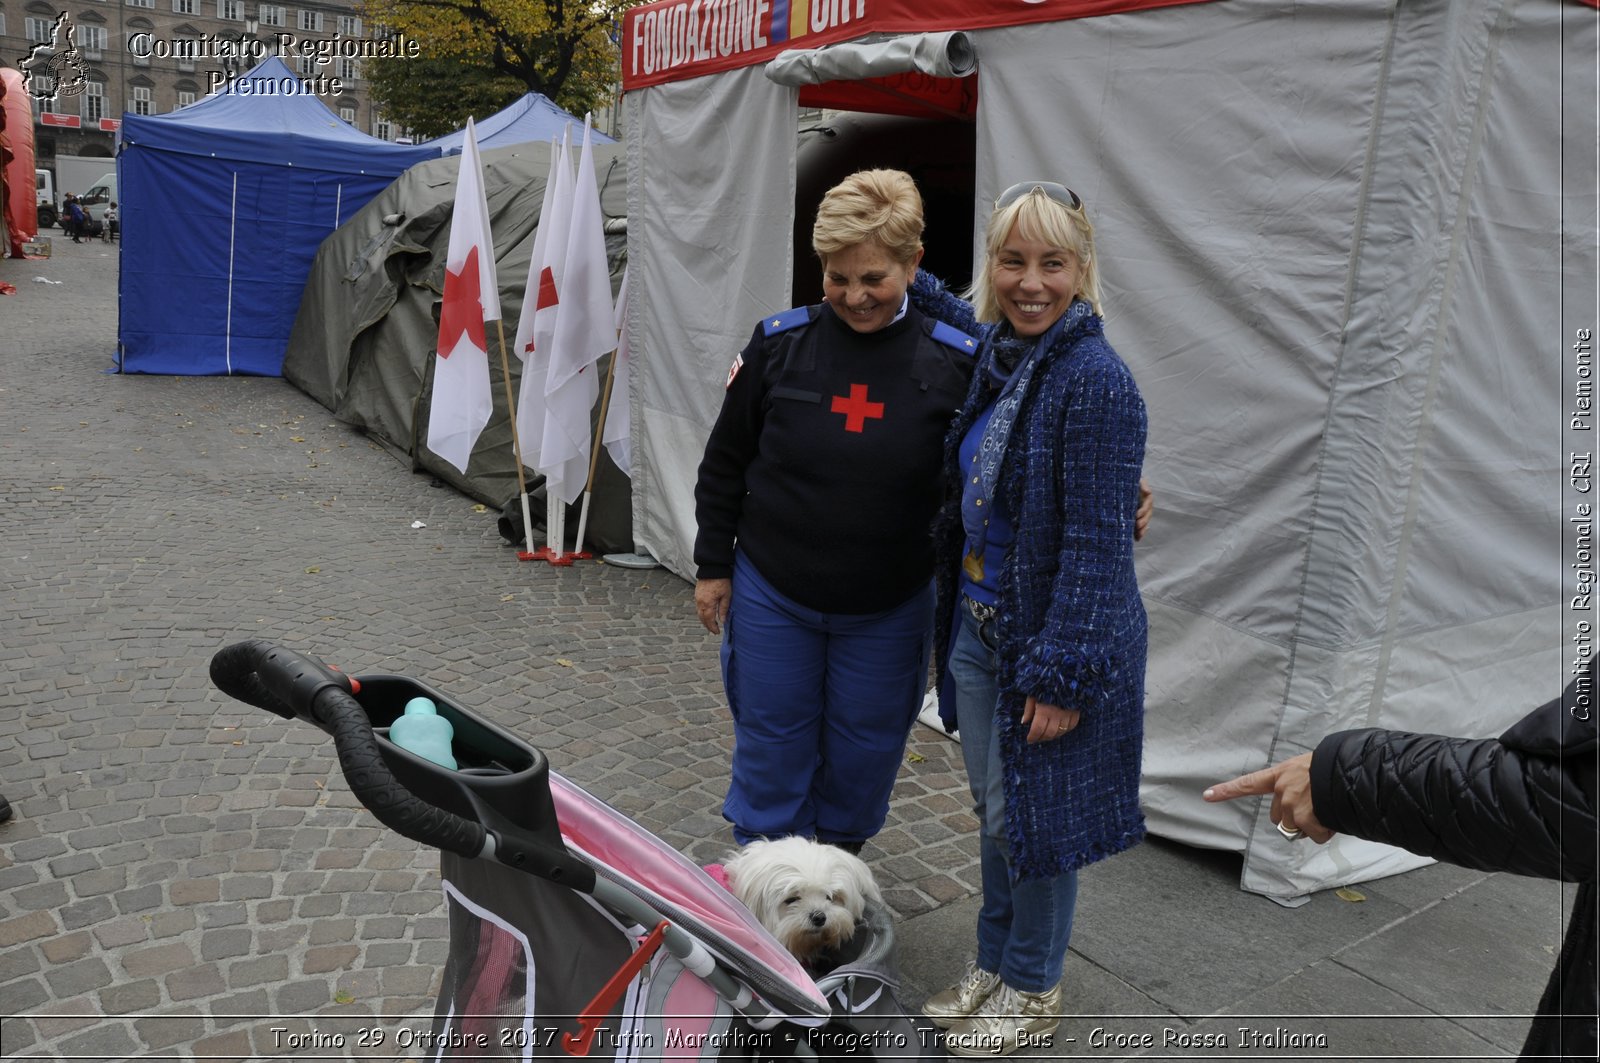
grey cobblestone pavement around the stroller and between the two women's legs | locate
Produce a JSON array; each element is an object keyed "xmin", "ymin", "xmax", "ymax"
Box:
[{"xmin": 0, "ymin": 240, "xmax": 976, "ymax": 1058}]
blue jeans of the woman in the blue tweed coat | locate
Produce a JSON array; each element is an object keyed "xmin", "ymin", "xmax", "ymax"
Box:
[{"xmin": 950, "ymin": 608, "xmax": 1078, "ymax": 993}]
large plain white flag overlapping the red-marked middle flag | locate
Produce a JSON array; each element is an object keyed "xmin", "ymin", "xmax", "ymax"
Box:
[{"xmin": 539, "ymin": 118, "xmax": 616, "ymax": 504}]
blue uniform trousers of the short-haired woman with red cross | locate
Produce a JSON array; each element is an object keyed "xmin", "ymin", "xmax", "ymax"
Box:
[{"xmin": 722, "ymin": 552, "xmax": 933, "ymax": 845}]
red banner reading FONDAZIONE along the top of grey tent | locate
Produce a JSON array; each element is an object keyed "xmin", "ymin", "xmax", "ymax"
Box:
[{"xmin": 622, "ymin": 0, "xmax": 1205, "ymax": 90}]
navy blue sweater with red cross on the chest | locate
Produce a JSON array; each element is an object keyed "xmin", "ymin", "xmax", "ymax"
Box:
[{"xmin": 694, "ymin": 304, "xmax": 973, "ymax": 615}]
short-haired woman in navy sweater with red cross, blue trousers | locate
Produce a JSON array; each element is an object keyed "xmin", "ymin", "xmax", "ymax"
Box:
[{"xmin": 694, "ymin": 170, "xmax": 978, "ymax": 850}]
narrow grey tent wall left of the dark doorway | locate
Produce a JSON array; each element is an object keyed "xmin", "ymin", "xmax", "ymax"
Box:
[{"xmin": 624, "ymin": 67, "xmax": 795, "ymax": 578}]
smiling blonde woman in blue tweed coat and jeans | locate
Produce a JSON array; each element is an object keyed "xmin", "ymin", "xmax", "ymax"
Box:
[{"xmin": 910, "ymin": 181, "xmax": 1147, "ymax": 1055}]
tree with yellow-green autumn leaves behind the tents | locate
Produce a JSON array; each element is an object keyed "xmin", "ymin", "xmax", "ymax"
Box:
[{"xmin": 363, "ymin": 0, "xmax": 643, "ymax": 138}]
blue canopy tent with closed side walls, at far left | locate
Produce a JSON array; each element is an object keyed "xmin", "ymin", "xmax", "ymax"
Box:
[{"xmin": 117, "ymin": 58, "xmax": 438, "ymax": 376}]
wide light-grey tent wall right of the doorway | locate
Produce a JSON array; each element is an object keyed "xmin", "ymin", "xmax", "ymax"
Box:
[{"xmin": 974, "ymin": 0, "xmax": 1595, "ymax": 903}]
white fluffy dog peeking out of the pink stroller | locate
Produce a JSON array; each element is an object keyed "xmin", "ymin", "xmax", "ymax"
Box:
[{"xmin": 723, "ymin": 837, "xmax": 883, "ymax": 964}]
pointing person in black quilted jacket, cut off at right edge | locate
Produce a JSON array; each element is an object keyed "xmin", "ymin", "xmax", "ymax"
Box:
[{"xmin": 1203, "ymin": 658, "xmax": 1600, "ymax": 1061}]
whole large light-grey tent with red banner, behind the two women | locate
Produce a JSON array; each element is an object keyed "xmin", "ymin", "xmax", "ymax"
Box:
[{"xmin": 622, "ymin": 0, "xmax": 1597, "ymax": 901}]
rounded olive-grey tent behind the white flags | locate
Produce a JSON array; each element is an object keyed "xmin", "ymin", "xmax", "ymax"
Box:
[{"xmin": 283, "ymin": 144, "xmax": 632, "ymax": 549}]
